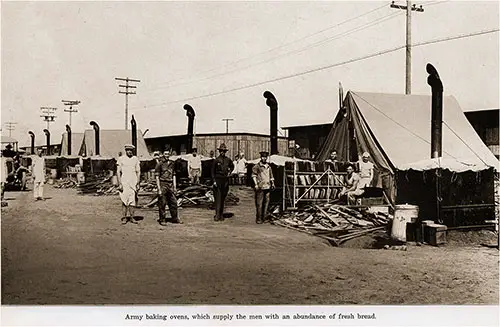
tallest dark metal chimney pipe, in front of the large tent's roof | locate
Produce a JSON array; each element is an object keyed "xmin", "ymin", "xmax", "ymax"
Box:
[{"xmin": 426, "ymin": 64, "xmax": 443, "ymax": 158}]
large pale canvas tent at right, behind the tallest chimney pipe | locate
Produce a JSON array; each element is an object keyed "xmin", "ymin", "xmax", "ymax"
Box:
[{"xmin": 317, "ymin": 91, "xmax": 499, "ymax": 200}]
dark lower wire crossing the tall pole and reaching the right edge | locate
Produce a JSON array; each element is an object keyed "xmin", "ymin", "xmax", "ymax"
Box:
[{"xmin": 131, "ymin": 29, "xmax": 499, "ymax": 110}]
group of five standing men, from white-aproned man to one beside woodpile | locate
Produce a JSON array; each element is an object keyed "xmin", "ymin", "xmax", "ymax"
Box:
[{"xmin": 117, "ymin": 143, "xmax": 274, "ymax": 225}]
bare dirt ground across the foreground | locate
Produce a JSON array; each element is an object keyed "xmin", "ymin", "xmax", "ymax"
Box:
[{"xmin": 1, "ymin": 186, "xmax": 499, "ymax": 305}]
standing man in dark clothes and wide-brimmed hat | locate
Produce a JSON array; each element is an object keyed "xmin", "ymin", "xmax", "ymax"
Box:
[{"xmin": 212, "ymin": 143, "xmax": 234, "ymax": 221}]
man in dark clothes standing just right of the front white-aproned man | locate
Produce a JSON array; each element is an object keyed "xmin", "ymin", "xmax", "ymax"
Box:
[{"xmin": 155, "ymin": 150, "xmax": 182, "ymax": 225}]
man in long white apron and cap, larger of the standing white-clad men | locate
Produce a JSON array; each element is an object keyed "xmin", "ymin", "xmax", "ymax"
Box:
[{"xmin": 116, "ymin": 144, "xmax": 141, "ymax": 224}]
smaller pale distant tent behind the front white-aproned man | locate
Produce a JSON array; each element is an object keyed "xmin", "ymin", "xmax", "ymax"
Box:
[{"xmin": 78, "ymin": 129, "xmax": 151, "ymax": 160}]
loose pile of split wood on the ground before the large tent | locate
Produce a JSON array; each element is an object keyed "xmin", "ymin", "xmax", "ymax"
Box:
[{"xmin": 272, "ymin": 204, "xmax": 392, "ymax": 246}]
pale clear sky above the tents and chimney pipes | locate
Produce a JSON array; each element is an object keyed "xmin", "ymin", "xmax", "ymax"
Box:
[{"xmin": 0, "ymin": 1, "xmax": 500, "ymax": 146}]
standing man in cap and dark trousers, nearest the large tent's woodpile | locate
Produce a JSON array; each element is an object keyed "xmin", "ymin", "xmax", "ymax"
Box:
[{"xmin": 252, "ymin": 151, "xmax": 274, "ymax": 224}]
